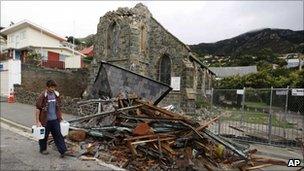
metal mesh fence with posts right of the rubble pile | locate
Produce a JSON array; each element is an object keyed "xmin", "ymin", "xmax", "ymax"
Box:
[{"xmin": 207, "ymin": 87, "xmax": 304, "ymax": 146}]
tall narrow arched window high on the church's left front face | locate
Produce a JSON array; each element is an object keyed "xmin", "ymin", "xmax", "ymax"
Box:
[{"xmin": 107, "ymin": 22, "xmax": 120, "ymax": 57}]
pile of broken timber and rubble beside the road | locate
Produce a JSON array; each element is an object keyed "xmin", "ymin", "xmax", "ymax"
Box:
[{"xmin": 63, "ymin": 97, "xmax": 286, "ymax": 170}]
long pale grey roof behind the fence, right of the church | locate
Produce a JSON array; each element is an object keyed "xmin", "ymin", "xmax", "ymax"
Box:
[{"xmin": 209, "ymin": 65, "xmax": 258, "ymax": 78}]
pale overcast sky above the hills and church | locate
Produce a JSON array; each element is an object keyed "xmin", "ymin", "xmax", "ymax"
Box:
[{"xmin": 1, "ymin": 1, "xmax": 303, "ymax": 44}]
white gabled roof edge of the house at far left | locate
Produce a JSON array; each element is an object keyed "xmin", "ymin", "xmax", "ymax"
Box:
[{"xmin": 0, "ymin": 20, "xmax": 66, "ymax": 41}]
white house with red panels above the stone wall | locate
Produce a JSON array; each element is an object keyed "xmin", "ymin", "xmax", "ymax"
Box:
[{"xmin": 0, "ymin": 20, "xmax": 85, "ymax": 69}]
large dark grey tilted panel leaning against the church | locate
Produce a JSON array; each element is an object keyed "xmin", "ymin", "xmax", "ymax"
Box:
[{"xmin": 88, "ymin": 62, "xmax": 172, "ymax": 104}]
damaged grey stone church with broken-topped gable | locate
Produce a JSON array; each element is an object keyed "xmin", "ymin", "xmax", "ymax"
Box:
[{"xmin": 89, "ymin": 3, "xmax": 213, "ymax": 113}]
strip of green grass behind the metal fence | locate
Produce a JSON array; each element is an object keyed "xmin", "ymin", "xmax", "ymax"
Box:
[{"xmin": 223, "ymin": 110, "xmax": 294, "ymax": 128}]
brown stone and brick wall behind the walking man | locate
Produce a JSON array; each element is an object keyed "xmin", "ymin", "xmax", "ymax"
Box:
[{"xmin": 14, "ymin": 64, "xmax": 89, "ymax": 114}]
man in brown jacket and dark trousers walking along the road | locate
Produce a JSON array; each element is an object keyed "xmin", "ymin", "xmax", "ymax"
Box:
[{"xmin": 36, "ymin": 80, "xmax": 67, "ymax": 157}]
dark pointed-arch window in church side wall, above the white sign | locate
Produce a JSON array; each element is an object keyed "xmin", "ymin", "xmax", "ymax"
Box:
[{"xmin": 159, "ymin": 55, "xmax": 171, "ymax": 85}]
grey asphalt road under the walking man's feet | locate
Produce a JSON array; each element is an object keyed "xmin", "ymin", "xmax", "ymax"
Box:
[{"xmin": 0, "ymin": 123, "xmax": 110, "ymax": 170}]
